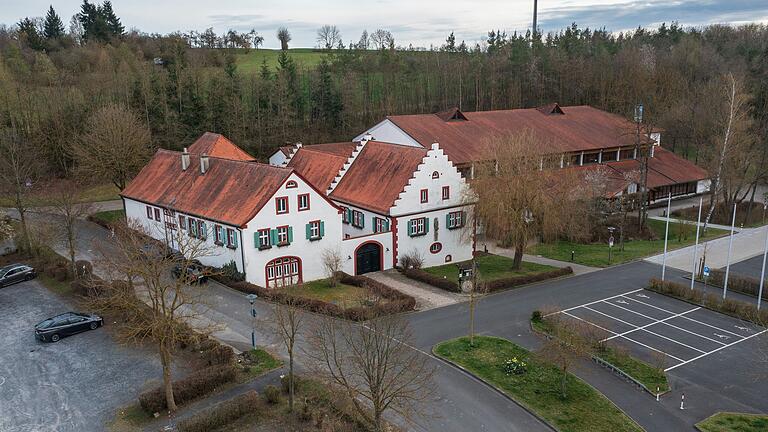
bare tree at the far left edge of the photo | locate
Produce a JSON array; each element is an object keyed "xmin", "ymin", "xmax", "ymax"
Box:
[{"xmin": 0, "ymin": 129, "xmax": 42, "ymax": 251}]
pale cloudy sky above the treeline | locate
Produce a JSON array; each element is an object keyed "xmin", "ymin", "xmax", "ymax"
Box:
[{"xmin": 0, "ymin": 0, "xmax": 768, "ymax": 48}]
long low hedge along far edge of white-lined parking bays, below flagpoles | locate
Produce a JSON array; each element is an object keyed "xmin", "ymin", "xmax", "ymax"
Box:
[{"xmin": 648, "ymin": 279, "xmax": 768, "ymax": 325}]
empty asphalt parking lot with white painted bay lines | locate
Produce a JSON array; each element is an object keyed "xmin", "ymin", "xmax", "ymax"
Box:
[{"xmin": 560, "ymin": 289, "xmax": 768, "ymax": 371}]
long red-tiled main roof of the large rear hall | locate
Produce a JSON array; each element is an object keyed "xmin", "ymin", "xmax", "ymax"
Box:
[{"xmin": 388, "ymin": 104, "xmax": 652, "ymax": 164}]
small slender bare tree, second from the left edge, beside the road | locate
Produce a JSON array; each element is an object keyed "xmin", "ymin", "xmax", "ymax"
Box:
[{"xmin": 48, "ymin": 181, "xmax": 93, "ymax": 275}]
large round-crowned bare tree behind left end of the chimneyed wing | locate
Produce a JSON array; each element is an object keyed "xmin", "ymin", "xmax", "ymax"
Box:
[{"xmin": 72, "ymin": 105, "xmax": 151, "ymax": 190}]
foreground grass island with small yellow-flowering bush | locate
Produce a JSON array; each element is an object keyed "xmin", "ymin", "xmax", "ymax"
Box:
[{"xmin": 434, "ymin": 336, "xmax": 643, "ymax": 432}]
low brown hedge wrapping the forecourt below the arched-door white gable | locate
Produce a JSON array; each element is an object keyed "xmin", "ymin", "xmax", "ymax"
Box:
[{"xmin": 211, "ymin": 272, "xmax": 416, "ymax": 321}]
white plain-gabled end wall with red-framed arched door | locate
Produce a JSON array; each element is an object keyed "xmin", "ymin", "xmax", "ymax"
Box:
[{"xmin": 242, "ymin": 173, "xmax": 342, "ymax": 286}]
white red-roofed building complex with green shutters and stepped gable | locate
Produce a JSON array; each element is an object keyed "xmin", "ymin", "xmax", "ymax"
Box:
[{"xmin": 122, "ymin": 134, "xmax": 473, "ymax": 287}]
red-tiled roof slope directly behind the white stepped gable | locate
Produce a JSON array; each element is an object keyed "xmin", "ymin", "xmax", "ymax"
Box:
[{"xmin": 330, "ymin": 141, "xmax": 427, "ymax": 214}]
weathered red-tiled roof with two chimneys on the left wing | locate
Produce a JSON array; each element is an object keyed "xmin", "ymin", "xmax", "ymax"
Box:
[{"xmin": 121, "ymin": 149, "xmax": 293, "ymax": 226}]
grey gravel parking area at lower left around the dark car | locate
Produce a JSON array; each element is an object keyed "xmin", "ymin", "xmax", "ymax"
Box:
[{"xmin": 0, "ymin": 280, "xmax": 167, "ymax": 432}]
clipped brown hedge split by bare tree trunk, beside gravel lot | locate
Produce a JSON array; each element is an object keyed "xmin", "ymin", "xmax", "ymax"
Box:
[{"xmin": 139, "ymin": 364, "xmax": 237, "ymax": 414}]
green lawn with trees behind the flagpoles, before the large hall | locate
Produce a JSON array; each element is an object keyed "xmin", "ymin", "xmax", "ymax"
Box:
[{"xmin": 527, "ymin": 219, "xmax": 728, "ymax": 267}]
